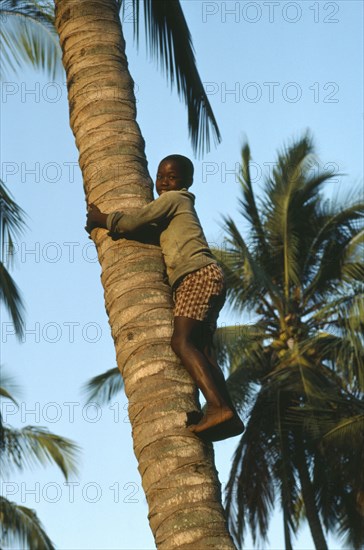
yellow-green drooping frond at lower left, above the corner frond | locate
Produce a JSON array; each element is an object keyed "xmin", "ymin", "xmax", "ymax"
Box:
[{"xmin": 1, "ymin": 426, "xmax": 79, "ymax": 479}]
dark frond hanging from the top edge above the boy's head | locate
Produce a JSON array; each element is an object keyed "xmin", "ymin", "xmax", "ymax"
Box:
[{"xmin": 133, "ymin": 0, "xmax": 221, "ymax": 155}]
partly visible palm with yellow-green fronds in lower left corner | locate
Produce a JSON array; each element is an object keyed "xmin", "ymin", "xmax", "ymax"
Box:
[{"xmin": 0, "ymin": 372, "xmax": 78, "ymax": 550}]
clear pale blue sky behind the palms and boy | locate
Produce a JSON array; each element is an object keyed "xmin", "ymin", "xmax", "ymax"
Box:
[{"xmin": 1, "ymin": 0, "xmax": 363, "ymax": 550}]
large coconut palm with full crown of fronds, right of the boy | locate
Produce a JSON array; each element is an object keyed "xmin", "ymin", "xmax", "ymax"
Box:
[{"xmin": 212, "ymin": 135, "xmax": 364, "ymax": 550}]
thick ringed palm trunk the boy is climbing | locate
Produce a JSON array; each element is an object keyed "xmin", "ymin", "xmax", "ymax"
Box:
[{"xmin": 55, "ymin": 0, "xmax": 234, "ymax": 550}]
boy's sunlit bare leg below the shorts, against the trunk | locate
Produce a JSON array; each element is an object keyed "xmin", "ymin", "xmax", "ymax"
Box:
[{"xmin": 171, "ymin": 317, "xmax": 234, "ymax": 433}]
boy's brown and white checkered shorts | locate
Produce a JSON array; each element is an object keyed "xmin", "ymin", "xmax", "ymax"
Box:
[{"xmin": 173, "ymin": 263, "xmax": 226, "ymax": 331}]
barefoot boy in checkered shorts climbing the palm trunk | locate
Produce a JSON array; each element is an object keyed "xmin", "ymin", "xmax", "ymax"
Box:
[{"xmin": 86, "ymin": 155, "xmax": 244, "ymax": 441}]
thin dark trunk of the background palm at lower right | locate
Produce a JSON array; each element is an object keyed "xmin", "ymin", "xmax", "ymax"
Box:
[{"xmin": 295, "ymin": 434, "xmax": 328, "ymax": 550}]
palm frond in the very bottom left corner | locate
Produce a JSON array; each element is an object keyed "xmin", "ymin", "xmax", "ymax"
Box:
[{"xmin": 0, "ymin": 497, "xmax": 55, "ymax": 550}]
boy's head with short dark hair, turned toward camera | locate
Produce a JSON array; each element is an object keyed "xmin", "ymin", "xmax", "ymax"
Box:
[{"xmin": 156, "ymin": 155, "xmax": 193, "ymax": 195}]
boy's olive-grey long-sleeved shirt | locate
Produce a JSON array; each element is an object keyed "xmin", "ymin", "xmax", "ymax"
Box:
[{"xmin": 106, "ymin": 189, "xmax": 215, "ymax": 286}]
